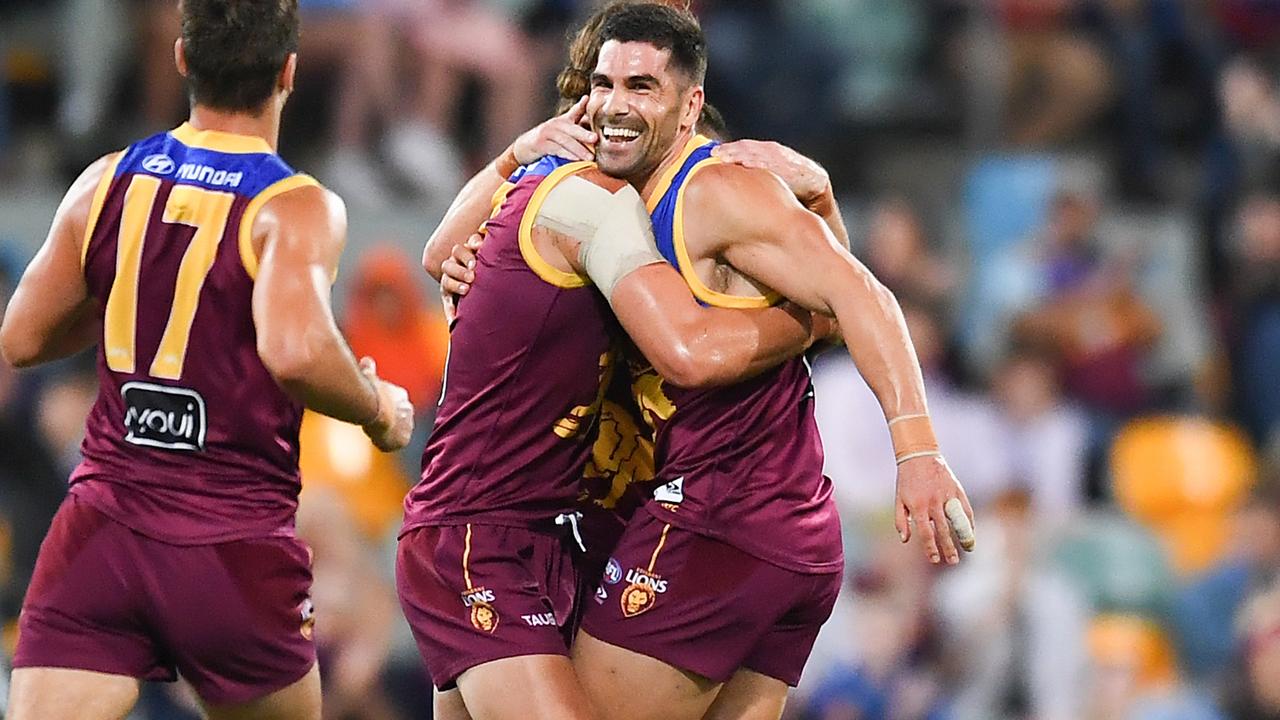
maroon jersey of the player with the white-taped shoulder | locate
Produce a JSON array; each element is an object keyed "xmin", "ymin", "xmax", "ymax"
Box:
[{"xmin": 404, "ymin": 158, "xmax": 616, "ymax": 532}]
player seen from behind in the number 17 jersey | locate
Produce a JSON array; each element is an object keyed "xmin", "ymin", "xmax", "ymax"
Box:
[{"xmin": 0, "ymin": 0, "xmax": 412, "ymax": 720}]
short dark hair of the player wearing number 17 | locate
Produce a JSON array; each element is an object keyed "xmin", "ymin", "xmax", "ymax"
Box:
[{"xmin": 182, "ymin": 0, "xmax": 298, "ymax": 111}]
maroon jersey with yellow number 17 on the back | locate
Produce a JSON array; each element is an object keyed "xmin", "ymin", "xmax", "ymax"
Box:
[{"xmin": 70, "ymin": 124, "xmax": 315, "ymax": 544}]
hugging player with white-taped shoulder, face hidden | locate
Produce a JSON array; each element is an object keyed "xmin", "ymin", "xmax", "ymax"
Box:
[{"xmin": 397, "ymin": 107, "xmax": 810, "ymax": 719}]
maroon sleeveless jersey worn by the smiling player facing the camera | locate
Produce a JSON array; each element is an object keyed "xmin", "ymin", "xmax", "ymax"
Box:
[{"xmin": 645, "ymin": 137, "xmax": 844, "ymax": 573}]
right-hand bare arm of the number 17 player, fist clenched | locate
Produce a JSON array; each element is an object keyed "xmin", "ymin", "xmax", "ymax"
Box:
[{"xmin": 253, "ymin": 186, "xmax": 413, "ymax": 450}]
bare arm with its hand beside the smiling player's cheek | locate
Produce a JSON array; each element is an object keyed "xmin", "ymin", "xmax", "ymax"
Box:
[{"xmin": 422, "ymin": 97, "xmax": 595, "ymax": 282}]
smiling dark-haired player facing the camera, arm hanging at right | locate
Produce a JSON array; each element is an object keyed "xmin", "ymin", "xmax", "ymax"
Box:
[{"xmin": 430, "ymin": 4, "xmax": 973, "ymax": 717}]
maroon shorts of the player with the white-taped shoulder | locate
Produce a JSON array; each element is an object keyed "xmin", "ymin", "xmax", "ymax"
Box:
[{"xmin": 396, "ymin": 524, "xmax": 579, "ymax": 691}]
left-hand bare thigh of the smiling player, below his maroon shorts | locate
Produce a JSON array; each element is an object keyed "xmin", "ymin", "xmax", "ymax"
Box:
[{"xmin": 573, "ymin": 630, "xmax": 721, "ymax": 720}]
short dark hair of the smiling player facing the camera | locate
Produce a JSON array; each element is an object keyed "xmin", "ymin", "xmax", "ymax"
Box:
[{"xmin": 600, "ymin": 3, "xmax": 707, "ymax": 85}]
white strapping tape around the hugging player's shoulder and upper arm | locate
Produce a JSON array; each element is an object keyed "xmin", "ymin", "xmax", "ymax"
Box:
[{"xmin": 535, "ymin": 176, "xmax": 663, "ymax": 300}]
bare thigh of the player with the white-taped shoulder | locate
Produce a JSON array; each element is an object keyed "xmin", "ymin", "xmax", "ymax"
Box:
[{"xmin": 458, "ymin": 655, "xmax": 593, "ymax": 720}]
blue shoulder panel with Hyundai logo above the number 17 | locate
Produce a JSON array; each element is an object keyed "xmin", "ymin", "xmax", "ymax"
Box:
[{"xmin": 115, "ymin": 132, "xmax": 296, "ymax": 197}]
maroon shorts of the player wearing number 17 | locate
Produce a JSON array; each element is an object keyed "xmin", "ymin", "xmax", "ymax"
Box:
[{"xmin": 14, "ymin": 493, "xmax": 316, "ymax": 706}]
